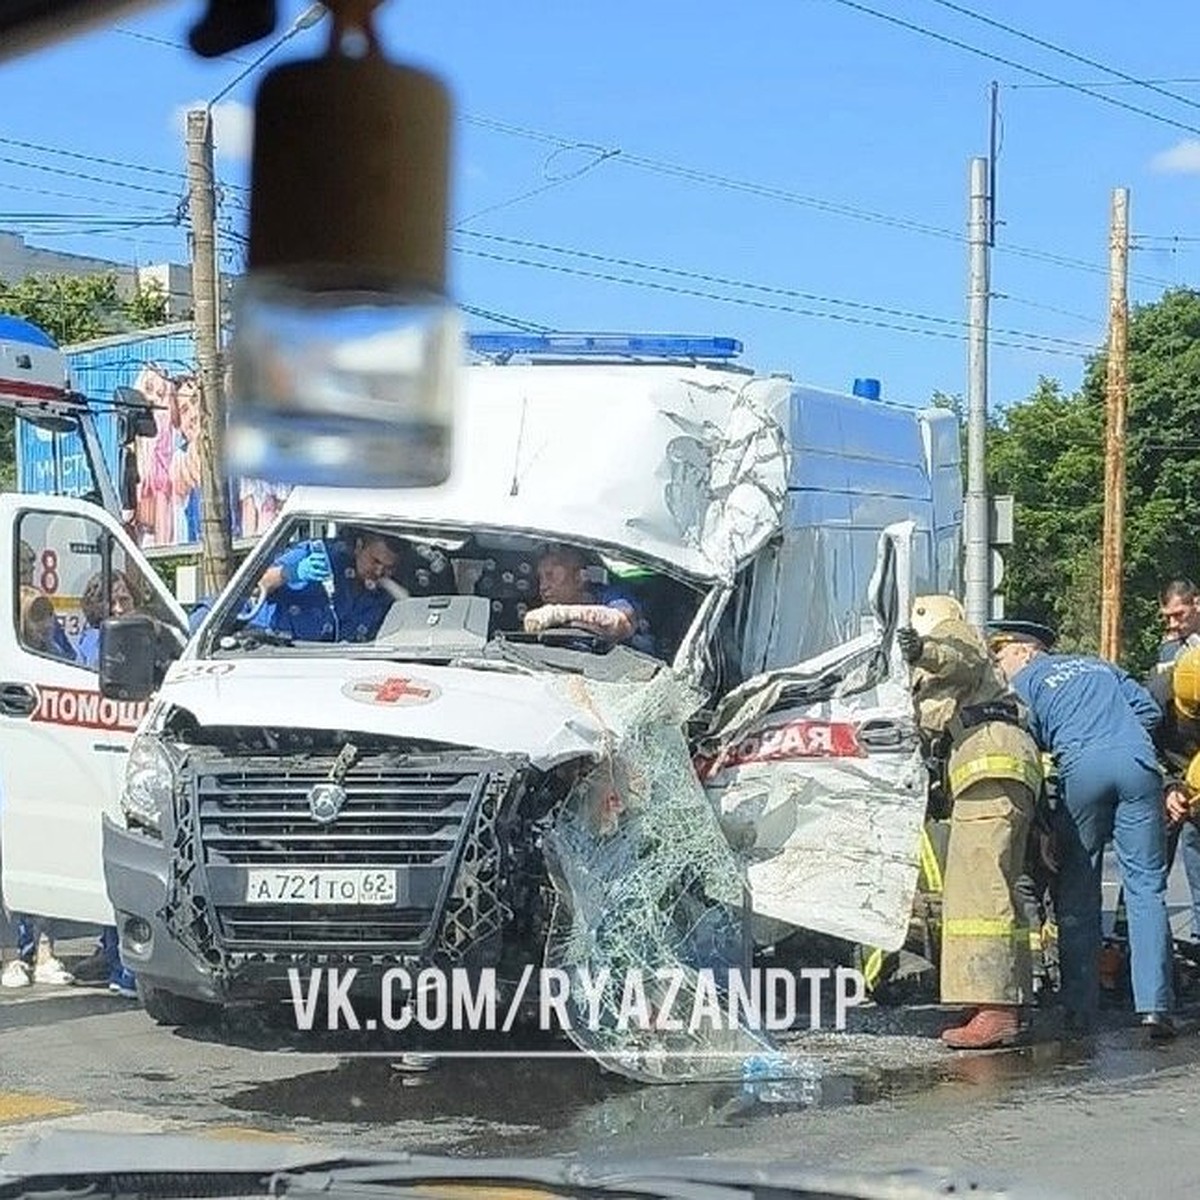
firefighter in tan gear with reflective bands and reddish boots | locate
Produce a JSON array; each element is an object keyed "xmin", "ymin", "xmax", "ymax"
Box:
[{"xmin": 896, "ymin": 595, "xmax": 1042, "ymax": 1050}]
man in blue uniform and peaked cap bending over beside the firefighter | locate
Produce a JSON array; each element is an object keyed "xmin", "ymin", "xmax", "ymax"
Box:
[{"xmin": 991, "ymin": 622, "xmax": 1175, "ymax": 1038}]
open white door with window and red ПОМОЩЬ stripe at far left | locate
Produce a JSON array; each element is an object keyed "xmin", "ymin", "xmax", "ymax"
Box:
[{"xmin": 0, "ymin": 494, "xmax": 187, "ymax": 924}]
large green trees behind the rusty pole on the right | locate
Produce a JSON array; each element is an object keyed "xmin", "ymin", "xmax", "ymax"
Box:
[{"xmin": 988, "ymin": 289, "xmax": 1200, "ymax": 671}]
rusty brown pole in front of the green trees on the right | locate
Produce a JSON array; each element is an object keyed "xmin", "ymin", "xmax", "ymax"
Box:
[{"xmin": 1100, "ymin": 187, "xmax": 1129, "ymax": 662}]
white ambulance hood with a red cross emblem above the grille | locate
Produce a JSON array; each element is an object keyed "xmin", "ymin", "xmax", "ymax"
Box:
[{"xmin": 151, "ymin": 658, "xmax": 606, "ymax": 770}]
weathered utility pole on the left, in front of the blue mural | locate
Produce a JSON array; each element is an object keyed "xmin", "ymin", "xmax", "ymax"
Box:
[{"xmin": 187, "ymin": 108, "xmax": 233, "ymax": 595}]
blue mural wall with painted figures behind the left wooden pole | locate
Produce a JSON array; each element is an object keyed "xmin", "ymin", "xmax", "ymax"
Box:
[{"xmin": 17, "ymin": 323, "xmax": 288, "ymax": 551}]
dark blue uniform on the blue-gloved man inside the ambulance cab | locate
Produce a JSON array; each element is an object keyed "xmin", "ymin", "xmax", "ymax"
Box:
[{"xmin": 254, "ymin": 541, "xmax": 391, "ymax": 642}]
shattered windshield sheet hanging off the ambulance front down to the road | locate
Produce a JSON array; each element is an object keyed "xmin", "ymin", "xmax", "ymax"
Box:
[{"xmin": 544, "ymin": 672, "xmax": 769, "ymax": 1082}]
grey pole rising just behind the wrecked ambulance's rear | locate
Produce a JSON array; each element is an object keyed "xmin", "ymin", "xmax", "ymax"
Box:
[{"xmin": 962, "ymin": 158, "xmax": 991, "ymax": 629}]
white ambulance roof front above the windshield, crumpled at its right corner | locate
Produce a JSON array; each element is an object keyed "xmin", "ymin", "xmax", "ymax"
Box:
[{"xmin": 277, "ymin": 365, "xmax": 792, "ymax": 581}]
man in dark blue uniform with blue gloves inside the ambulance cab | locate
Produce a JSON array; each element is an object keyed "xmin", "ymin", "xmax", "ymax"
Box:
[{"xmin": 253, "ymin": 532, "xmax": 400, "ymax": 642}]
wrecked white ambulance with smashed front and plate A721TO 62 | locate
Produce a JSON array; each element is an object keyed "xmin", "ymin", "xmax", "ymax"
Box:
[{"xmin": 5, "ymin": 343, "xmax": 961, "ymax": 1049}]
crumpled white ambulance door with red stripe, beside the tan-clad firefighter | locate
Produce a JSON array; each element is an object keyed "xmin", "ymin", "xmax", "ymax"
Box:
[{"xmin": 697, "ymin": 522, "xmax": 926, "ymax": 950}]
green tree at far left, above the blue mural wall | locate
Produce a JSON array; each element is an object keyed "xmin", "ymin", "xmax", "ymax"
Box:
[{"xmin": 0, "ymin": 272, "xmax": 167, "ymax": 488}]
